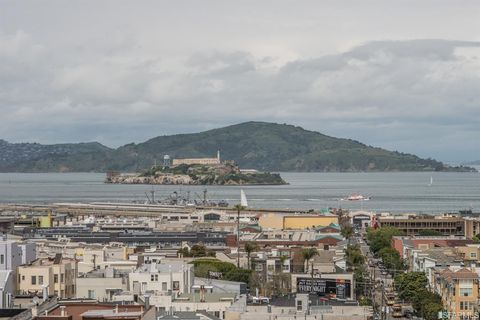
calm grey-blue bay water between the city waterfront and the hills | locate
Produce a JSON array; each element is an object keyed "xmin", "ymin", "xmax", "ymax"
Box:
[{"xmin": 0, "ymin": 172, "xmax": 480, "ymax": 213}]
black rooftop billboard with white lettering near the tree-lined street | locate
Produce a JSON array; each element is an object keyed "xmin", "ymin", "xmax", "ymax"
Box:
[{"xmin": 297, "ymin": 278, "xmax": 351, "ymax": 299}]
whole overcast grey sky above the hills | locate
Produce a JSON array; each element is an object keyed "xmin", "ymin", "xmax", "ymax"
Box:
[{"xmin": 0, "ymin": 0, "xmax": 480, "ymax": 162}]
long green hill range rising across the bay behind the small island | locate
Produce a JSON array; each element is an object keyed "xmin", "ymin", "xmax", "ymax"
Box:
[{"xmin": 0, "ymin": 122, "xmax": 473, "ymax": 172}]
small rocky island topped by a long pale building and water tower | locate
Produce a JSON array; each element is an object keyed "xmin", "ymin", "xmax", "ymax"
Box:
[{"xmin": 105, "ymin": 156, "xmax": 287, "ymax": 185}]
